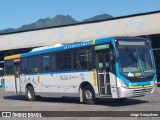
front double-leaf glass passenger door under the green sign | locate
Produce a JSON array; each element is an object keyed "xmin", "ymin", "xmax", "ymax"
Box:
[{"xmin": 96, "ymin": 49, "xmax": 111, "ymax": 96}]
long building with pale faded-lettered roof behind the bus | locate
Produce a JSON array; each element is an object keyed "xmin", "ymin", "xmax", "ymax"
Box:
[{"xmin": 0, "ymin": 11, "xmax": 160, "ymax": 79}]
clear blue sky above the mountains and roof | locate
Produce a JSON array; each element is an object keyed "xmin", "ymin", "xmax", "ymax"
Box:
[{"xmin": 0, "ymin": 0, "xmax": 160, "ymax": 30}]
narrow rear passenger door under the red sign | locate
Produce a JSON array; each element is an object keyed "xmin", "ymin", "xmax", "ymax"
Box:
[{"xmin": 14, "ymin": 59, "xmax": 21, "ymax": 94}]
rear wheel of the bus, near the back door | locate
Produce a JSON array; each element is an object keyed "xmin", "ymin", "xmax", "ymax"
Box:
[{"xmin": 26, "ymin": 86, "xmax": 35, "ymax": 101}]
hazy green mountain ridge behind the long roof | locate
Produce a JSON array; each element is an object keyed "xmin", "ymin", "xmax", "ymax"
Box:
[{"xmin": 0, "ymin": 14, "xmax": 113, "ymax": 34}]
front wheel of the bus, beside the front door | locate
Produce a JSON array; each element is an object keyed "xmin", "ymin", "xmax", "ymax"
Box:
[{"xmin": 82, "ymin": 85, "xmax": 95, "ymax": 104}]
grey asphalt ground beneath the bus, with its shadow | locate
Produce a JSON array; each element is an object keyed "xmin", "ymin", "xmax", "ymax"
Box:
[{"xmin": 0, "ymin": 87, "xmax": 160, "ymax": 120}]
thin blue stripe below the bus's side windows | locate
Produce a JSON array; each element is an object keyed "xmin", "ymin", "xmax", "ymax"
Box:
[{"xmin": 21, "ymin": 70, "xmax": 92, "ymax": 76}]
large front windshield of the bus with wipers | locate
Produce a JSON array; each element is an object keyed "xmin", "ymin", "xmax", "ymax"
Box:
[{"xmin": 118, "ymin": 41, "xmax": 155, "ymax": 78}]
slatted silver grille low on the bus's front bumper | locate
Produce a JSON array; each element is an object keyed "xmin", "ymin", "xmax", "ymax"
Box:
[{"xmin": 133, "ymin": 88, "xmax": 153, "ymax": 96}]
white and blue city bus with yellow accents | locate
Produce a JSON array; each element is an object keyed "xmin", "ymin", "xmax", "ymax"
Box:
[{"xmin": 4, "ymin": 37, "xmax": 157, "ymax": 104}]
